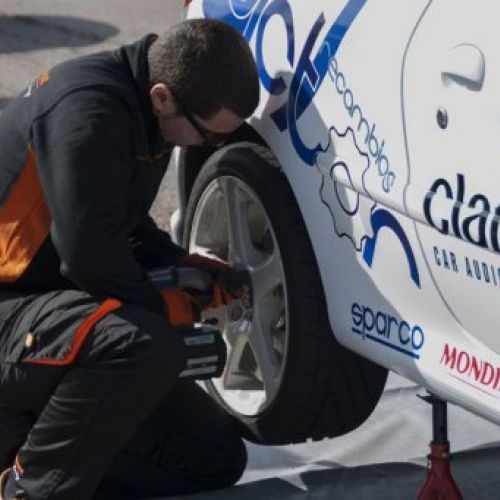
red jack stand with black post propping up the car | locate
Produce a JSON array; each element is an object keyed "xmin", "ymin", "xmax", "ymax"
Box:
[{"xmin": 418, "ymin": 395, "xmax": 463, "ymax": 500}]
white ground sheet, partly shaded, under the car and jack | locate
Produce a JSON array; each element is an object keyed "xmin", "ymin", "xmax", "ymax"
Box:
[{"xmin": 169, "ymin": 374, "xmax": 500, "ymax": 500}]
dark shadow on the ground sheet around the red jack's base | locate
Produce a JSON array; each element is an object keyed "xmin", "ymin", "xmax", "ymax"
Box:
[{"xmin": 161, "ymin": 447, "xmax": 500, "ymax": 500}]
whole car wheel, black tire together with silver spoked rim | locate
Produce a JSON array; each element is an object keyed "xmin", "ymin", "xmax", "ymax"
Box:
[{"xmin": 184, "ymin": 144, "xmax": 387, "ymax": 444}]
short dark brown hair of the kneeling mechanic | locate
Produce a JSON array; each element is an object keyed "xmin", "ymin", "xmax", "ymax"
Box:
[{"xmin": 148, "ymin": 19, "xmax": 260, "ymax": 118}]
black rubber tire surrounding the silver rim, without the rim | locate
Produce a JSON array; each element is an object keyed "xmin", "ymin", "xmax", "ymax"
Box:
[{"xmin": 184, "ymin": 144, "xmax": 387, "ymax": 444}]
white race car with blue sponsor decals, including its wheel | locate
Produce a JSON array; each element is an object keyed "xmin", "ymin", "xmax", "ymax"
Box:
[{"xmin": 172, "ymin": 0, "xmax": 500, "ymax": 444}]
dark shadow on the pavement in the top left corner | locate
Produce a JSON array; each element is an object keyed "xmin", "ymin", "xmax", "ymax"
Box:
[{"xmin": 0, "ymin": 14, "xmax": 119, "ymax": 54}]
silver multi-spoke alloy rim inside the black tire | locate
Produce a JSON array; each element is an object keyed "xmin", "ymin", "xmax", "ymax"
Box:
[{"xmin": 189, "ymin": 176, "xmax": 289, "ymax": 416}]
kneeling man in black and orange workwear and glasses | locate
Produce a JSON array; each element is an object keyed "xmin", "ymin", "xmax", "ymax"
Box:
[{"xmin": 0, "ymin": 20, "xmax": 259, "ymax": 500}]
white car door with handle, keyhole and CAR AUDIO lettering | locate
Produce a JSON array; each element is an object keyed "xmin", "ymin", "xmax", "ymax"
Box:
[{"xmin": 403, "ymin": 0, "xmax": 500, "ymax": 353}]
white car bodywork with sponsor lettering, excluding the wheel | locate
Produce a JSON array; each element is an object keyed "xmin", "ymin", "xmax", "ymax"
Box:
[{"xmin": 188, "ymin": 0, "xmax": 500, "ymax": 423}]
